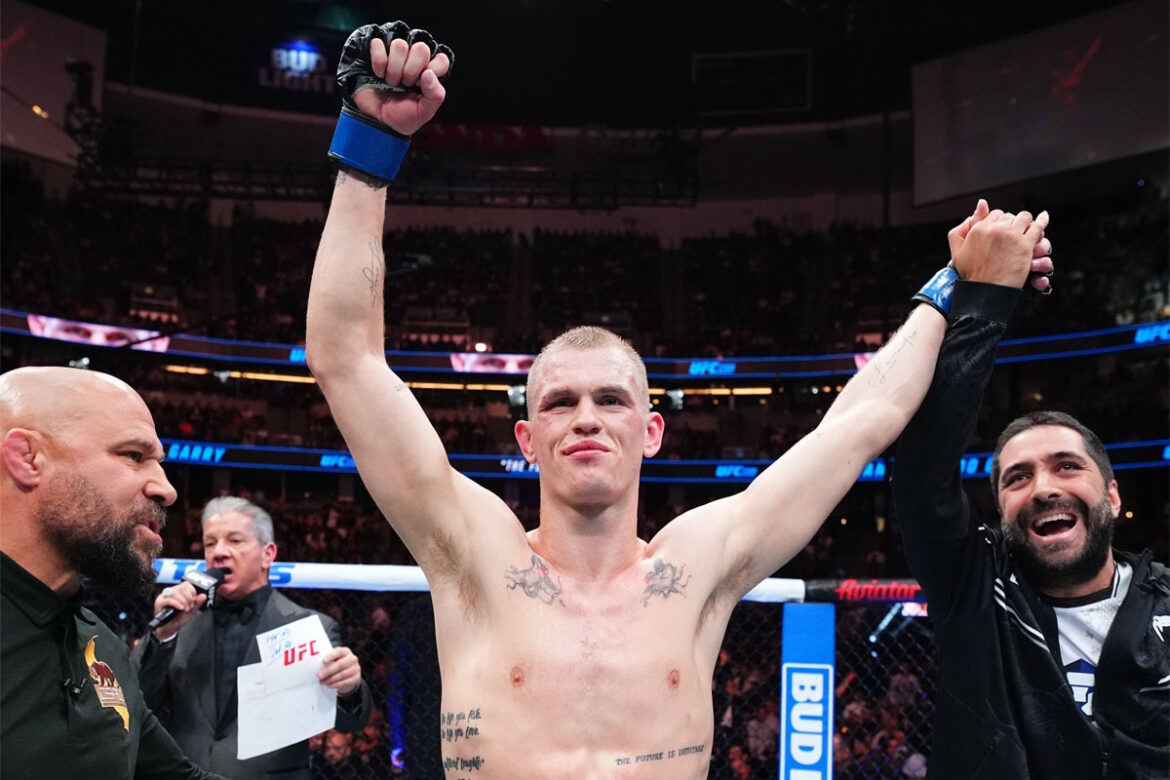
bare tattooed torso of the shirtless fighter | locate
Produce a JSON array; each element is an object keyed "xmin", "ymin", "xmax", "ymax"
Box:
[{"xmin": 432, "ymin": 519, "xmax": 734, "ymax": 780}]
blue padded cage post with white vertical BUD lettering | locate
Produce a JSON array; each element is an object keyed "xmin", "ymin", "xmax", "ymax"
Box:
[{"xmin": 780, "ymin": 603, "xmax": 835, "ymax": 780}]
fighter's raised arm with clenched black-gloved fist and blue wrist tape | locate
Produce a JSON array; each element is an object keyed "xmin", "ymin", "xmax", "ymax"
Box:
[{"xmin": 305, "ymin": 22, "xmax": 477, "ymax": 562}]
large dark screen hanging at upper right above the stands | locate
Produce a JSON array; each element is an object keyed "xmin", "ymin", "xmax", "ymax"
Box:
[{"xmin": 913, "ymin": 0, "xmax": 1170, "ymax": 203}]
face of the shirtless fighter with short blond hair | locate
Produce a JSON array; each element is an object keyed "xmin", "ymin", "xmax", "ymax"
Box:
[{"xmin": 516, "ymin": 346, "xmax": 662, "ymax": 505}]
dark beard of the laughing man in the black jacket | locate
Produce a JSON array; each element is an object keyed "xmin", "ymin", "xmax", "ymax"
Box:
[{"xmin": 1004, "ymin": 496, "xmax": 1113, "ymax": 588}]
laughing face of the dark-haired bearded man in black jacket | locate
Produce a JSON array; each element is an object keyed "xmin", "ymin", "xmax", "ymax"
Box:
[{"xmin": 999, "ymin": 426, "xmax": 1121, "ymax": 587}]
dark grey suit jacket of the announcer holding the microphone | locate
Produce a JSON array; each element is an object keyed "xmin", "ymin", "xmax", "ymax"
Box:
[{"xmin": 131, "ymin": 591, "xmax": 373, "ymax": 780}]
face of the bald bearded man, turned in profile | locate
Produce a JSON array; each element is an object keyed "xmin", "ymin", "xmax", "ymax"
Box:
[{"xmin": 37, "ymin": 392, "xmax": 176, "ymax": 596}]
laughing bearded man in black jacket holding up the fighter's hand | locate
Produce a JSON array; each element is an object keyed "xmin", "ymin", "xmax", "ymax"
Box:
[{"xmin": 894, "ymin": 282, "xmax": 1170, "ymax": 780}]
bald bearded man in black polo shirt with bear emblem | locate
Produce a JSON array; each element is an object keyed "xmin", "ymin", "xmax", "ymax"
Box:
[{"xmin": 0, "ymin": 367, "xmax": 228, "ymax": 780}]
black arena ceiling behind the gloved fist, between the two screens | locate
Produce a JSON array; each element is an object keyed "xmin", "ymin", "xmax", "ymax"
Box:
[{"xmin": 25, "ymin": 0, "xmax": 1119, "ymax": 127}]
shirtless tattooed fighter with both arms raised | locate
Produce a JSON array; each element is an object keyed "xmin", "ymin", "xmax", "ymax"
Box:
[{"xmin": 307, "ymin": 23, "xmax": 1051, "ymax": 780}]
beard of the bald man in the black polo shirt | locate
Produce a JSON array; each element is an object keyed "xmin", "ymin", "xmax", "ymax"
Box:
[{"xmin": 37, "ymin": 475, "xmax": 166, "ymax": 600}]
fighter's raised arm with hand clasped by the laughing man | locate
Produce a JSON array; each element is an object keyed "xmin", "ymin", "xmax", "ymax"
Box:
[{"xmin": 668, "ymin": 200, "xmax": 1052, "ymax": 599}]
